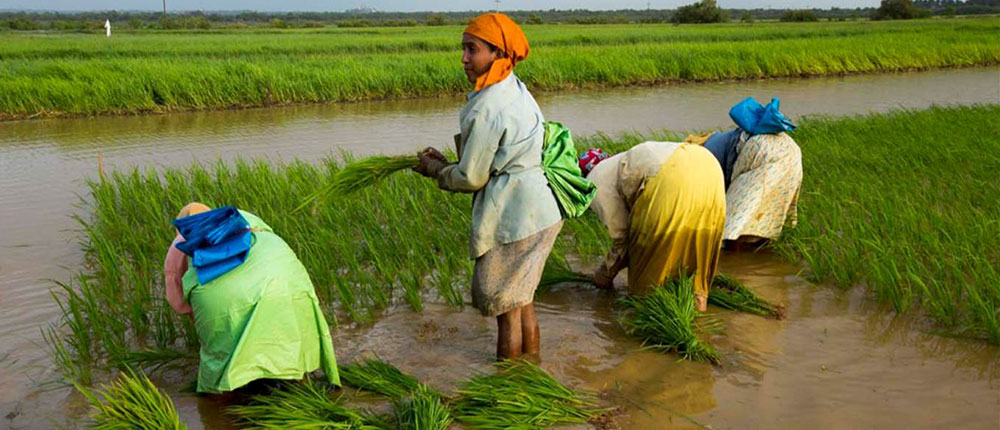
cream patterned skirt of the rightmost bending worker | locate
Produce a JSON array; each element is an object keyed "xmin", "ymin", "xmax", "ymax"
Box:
[{"xmin": 722, "ymin": 133, "xmax": 802, "ymax": 240}]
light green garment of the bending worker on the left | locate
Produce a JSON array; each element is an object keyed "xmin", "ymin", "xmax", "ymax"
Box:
[{"xmin": 184, "ymin": 211, "xmax": 340, "ymax": 393}]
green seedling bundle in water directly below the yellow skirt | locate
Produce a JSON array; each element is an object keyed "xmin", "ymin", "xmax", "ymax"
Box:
[{"xmin": 620, "ymin": 277, "xmax": 720, "ymax": 364}]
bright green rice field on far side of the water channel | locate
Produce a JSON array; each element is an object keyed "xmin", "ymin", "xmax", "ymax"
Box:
[{"xmin": 0, "ymin": 18, "xmax": 1000, "ymax": 119}]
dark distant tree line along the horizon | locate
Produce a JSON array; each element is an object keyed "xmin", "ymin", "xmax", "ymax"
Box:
[{"xmin": 0, "ymin": 0, "xmax": 1000, "ymax": 31}]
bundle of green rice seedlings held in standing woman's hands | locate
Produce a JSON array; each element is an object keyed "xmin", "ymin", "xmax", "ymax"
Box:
[{"xmin": 293, "ymin": 155, "xmax": 420, "ymax": 212}]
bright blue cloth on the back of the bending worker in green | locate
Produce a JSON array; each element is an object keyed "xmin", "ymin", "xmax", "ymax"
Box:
[{"xmin": 174, "ymin": 206, "xmax": 253, "ymax": 285}]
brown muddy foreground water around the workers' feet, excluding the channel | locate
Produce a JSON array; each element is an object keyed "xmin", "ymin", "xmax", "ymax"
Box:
[{"xmin": 164, "ymin": 255, "xmax": 1000, "ymax": 429}]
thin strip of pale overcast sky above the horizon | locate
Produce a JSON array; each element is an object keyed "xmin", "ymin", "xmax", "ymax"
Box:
[{"xmin": 0, "ymin": 0, "xmax": 879, "ymax": 12}]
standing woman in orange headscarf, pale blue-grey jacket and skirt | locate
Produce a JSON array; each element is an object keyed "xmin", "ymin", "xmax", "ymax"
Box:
[{"xmin": 415, "ymin": 13, "xmax": 562, "ymax": 359}]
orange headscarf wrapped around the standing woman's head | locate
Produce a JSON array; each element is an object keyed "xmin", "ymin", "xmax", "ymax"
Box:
[{"xmin": 465, "ymin": 13, "xmax": 529, "ymax": 91}]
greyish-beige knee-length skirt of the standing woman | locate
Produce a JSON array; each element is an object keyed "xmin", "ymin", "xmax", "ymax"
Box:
[{"xmin": 472, "ymin": 220, "xmax": 563, "ymax": 317}]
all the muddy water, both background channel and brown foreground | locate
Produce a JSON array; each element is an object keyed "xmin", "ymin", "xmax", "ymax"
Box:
[{"xmin": 0, "ymin": 68, "xmax": 1000, "ymax": 428}]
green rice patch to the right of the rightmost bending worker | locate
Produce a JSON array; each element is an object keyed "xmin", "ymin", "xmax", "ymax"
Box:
[{"xmin": 775, "ymin": 105, "xmax": 1000, "ymax": 344}]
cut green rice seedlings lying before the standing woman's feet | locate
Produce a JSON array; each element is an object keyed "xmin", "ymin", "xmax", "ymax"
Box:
[{"xmin": 453, "ymin": 360, "xmax": 602, "ymax": 429}]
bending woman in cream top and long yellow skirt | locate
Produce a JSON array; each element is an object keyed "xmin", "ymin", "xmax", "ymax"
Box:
[{"xmin": 588, "ymin": 142, "xmax": 726, "ymax": 295}]
